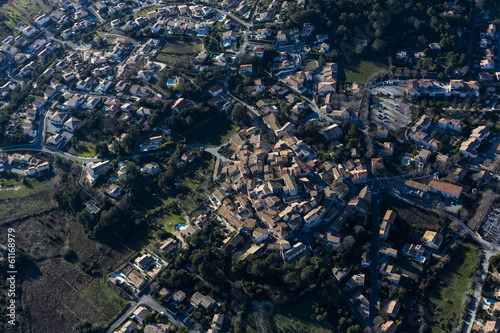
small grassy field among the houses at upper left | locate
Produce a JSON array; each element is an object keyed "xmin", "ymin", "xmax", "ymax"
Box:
[{"xmin": 156, "ymin": 39, "xmax": 201, "ymax": 67}]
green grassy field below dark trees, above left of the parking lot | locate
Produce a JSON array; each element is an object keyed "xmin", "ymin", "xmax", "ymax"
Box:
[{"xmin": 338, "ymin": 58, "xmax": 387, "ymax": 82}]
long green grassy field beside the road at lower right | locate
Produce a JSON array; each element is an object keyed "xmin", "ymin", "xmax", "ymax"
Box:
[{"xmin": 427, "ymin": 243, "xmax": 479, "ymax": 333}]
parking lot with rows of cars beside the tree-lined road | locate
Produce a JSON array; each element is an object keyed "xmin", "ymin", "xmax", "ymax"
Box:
[{"xmin": 371, "ymin": 96, "xmax": 411, "ymax": 131}]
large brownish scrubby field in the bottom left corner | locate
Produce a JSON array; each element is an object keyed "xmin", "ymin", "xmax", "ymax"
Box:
[{"xmin": 23, "ymin": 258, "xmax": 126, "ymax": 332}]
